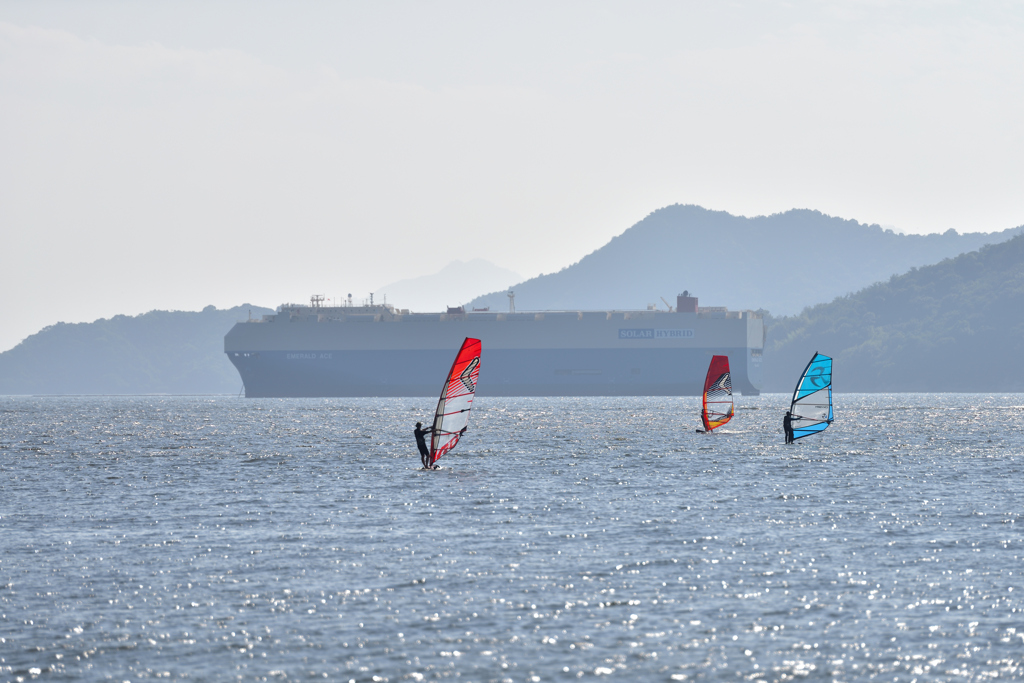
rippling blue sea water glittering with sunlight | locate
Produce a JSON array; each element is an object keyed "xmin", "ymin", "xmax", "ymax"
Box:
[{"xmin": 0, "ymin": 394, "xmax": 1024, "ymax": 681}]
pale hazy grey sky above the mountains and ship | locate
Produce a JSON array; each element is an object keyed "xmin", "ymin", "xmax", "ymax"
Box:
[{"xmin": 0, "ymin": 0, "xmax": 1024, "ymax": 350}]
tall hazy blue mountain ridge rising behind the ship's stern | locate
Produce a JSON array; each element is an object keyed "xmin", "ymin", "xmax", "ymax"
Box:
[{"xmin": 470, "ymin": 205, "xmax": 1024, "ymax": 315}]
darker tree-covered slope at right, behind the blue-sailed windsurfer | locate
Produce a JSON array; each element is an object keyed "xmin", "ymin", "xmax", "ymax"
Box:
[{"xmin": 764, "ymin": 236, "xmax": 1024, "ymax": 391}]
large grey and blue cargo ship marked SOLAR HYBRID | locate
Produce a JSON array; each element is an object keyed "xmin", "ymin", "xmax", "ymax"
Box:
[{"xmin": 224, "ymin": 293, "xmax": 765, "ymax": 397}]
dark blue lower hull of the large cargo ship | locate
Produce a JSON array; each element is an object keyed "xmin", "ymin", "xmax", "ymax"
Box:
[{"xmin": 228, "ymin": 348, "xmax": 760, "ymax": 397}]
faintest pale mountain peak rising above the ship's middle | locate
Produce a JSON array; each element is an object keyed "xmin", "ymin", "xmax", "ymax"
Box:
[{"xmin": 374, "ymin": 258, "xmax": 522, "ymax": 311}]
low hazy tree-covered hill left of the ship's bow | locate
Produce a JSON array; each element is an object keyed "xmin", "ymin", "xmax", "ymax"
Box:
[{"xmin": 0, "ymin": 304, "xmax": 273, "ymax": 394}]
